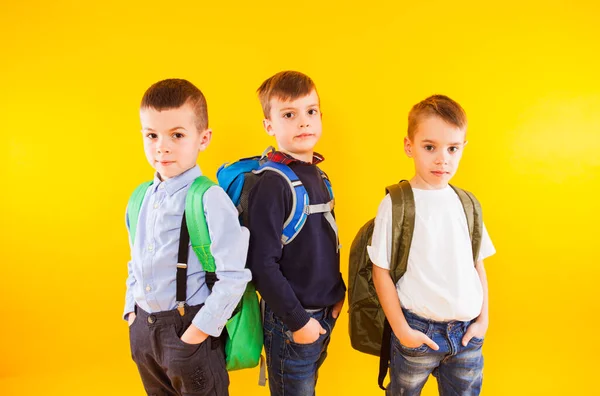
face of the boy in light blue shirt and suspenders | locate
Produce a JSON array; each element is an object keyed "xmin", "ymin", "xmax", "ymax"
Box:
[{"xmin": 140, "ymin": 104, "xmax": 212, "ymax": 180}]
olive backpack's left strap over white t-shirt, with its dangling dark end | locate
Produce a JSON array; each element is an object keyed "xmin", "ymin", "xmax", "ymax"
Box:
[{"xmin": 377, "ymin": 180, "xmax": 415, "ymax": 390}]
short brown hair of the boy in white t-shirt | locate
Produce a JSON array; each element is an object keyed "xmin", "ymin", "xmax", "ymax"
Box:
[{"xmin": 408, "ymin": 95, "xmax": 467, "ymax": 140}]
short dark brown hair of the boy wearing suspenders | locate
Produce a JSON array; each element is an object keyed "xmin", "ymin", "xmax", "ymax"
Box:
[{"xmin": 140, "ymin": 78, "xmax": 208, "ymax": 132}]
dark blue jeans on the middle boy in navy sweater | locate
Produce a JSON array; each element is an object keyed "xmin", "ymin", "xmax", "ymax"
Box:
[{"xmin": 264, "ymin": 305, "xmax": 336, "ymax": 396}]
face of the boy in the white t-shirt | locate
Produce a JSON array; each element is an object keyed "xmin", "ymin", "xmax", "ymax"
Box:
[{"xmin": 404, "ymin": 116, "xmax": 467, "ymax": 190}]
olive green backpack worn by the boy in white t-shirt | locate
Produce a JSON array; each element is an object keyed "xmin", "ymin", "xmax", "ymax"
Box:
[{"xmin": 348, "ymin": 180, "xmax": 483, "ymax": 389}]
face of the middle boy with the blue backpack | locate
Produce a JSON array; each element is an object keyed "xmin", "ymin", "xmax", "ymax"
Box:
[{"xmin": 263, "ymin": 90, "xmax": 321, "ymax": 163}]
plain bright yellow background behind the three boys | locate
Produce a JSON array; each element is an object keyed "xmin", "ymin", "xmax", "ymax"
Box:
[{"xmin": 0, "ymin": 0, "xmax": 600, "ymax": 396}]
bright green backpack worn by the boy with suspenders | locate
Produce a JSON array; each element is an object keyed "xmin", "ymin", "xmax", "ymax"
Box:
[{"xmin": 127, "ymin": 176, "xmax": 263, "ymax": 371}]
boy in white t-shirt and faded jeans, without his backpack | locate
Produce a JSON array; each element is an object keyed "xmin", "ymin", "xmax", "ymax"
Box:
[{"xmin": 367, "ymin": 95, "xmax": 495, "ymax": 396}]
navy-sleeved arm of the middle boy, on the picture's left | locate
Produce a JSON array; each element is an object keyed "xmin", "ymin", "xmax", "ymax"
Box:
[{"xmin": 248, "ymin": 172, "xmax": 310, "ymax": 332}]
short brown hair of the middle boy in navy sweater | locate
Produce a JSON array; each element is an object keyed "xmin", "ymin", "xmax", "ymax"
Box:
[{"xmin": 256, "ymin": 70, "xmax": 317, "ymax": 118}]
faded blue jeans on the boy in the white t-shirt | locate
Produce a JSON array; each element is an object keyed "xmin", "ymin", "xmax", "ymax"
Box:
[{"xmin": 386, "ymin": 310, "xmax": 483, "ymax": 396}]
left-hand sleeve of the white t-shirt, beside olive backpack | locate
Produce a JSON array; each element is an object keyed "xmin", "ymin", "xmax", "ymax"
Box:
[{"xmin": 367, "ymin": 194, "xmax": 392, "ymax": 270}]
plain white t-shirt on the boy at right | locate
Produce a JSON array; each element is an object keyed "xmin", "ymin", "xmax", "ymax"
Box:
[{"xmin": 367, "ymin": 186, "xmax": 496, "ymax": 321}]
